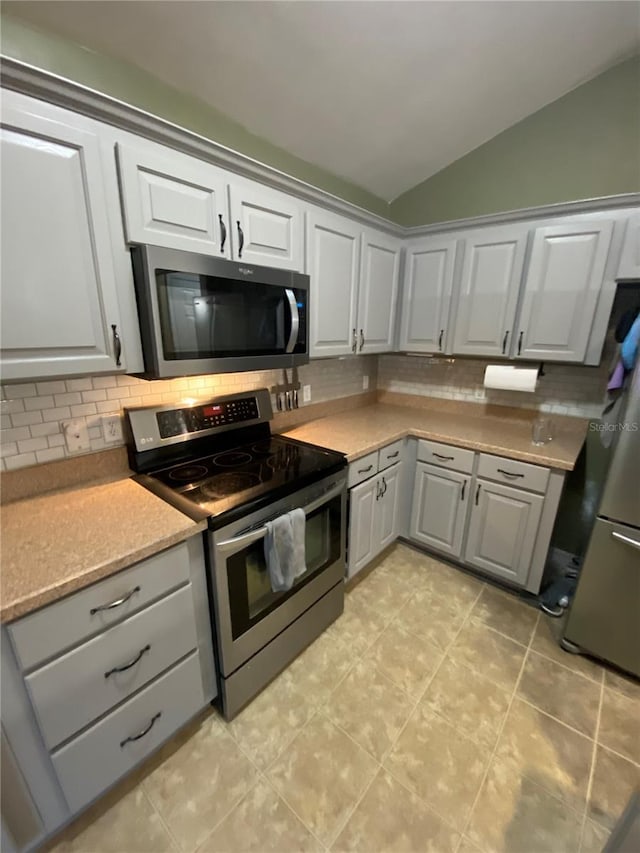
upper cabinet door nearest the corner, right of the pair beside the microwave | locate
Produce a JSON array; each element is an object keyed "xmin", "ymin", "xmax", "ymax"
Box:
[{"xmin": 358, "ymin": 231, "xmax": 401, "ymax": 353}]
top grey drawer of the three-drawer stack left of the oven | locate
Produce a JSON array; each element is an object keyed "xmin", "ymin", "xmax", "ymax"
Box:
[{"xmin": 8, "ymin": 542, "xmax": 189, "ymax": 670}]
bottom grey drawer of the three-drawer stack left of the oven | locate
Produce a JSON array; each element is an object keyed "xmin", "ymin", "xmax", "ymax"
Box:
[{"xmin": 51, "ymin": 653, "xmax": 205, "ymax": 812}]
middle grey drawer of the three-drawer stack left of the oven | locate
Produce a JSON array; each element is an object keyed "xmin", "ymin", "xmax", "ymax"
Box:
[{"xmin": 25, "ymin": 585, "xmax": 198, "ymax": 749}]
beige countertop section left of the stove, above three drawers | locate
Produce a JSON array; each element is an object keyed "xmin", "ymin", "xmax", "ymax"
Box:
[{"xmin": 0, "ymin": 479, "xmax": 206, "ymax": 622}]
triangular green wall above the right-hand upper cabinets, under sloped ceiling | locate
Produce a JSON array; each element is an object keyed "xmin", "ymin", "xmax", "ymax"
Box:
[{"xmin": 391, "ymin": 57, "xmax": 640, "ymax": 225}]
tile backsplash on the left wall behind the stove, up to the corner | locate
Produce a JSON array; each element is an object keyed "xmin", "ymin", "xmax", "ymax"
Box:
[{"xmin": 0, "ymin": 356, "xmax": 378, "ymax": 470}]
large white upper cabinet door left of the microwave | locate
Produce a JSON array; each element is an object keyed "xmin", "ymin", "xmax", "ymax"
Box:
[{"xmin": 1, "ymin": 92, "xmax": 125, "ymax": 379}]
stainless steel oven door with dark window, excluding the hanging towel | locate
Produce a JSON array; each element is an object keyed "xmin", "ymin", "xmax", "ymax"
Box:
[{"xmin": 210, "ymin": 474, "xmax": 346, "ymax": 677}]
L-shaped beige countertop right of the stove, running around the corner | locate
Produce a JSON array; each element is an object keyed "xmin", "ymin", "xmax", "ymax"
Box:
[{"xmin": 287, "ymin": 394, "xmax": 588, "ymax": 471}]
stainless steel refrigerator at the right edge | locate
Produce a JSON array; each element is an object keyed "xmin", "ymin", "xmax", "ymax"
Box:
[{"xmin": 563, "ymin": 358, "xmax": 640, "ymax": 677}]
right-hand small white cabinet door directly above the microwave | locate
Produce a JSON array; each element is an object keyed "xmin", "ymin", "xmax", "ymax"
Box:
[{"xmin": 229, "ymin": 180, "xmax": 304, "ymax": 270}]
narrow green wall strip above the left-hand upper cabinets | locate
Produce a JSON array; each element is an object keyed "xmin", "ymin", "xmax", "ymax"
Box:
[{"xmin": 0, "ymin": 15, "xmax": 389, "ymax": 217}]
